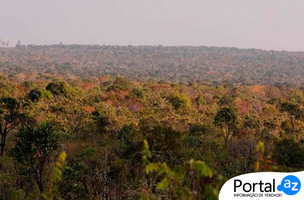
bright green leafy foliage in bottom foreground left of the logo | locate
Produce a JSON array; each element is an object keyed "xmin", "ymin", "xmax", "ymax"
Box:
[{"xmin": 142, "ymin": 140, "xmax": 223, "ymax": 200}]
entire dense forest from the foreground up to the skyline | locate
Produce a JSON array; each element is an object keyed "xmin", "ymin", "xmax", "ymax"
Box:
[{"xmin": 0, "ymin": 45, "xmax": 304, "ymax": 200}]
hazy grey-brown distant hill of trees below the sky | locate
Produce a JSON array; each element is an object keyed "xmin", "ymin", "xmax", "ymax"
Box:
[{"xmin": 0, "ymin": 45, "xmax": 304, "ymax": 86}]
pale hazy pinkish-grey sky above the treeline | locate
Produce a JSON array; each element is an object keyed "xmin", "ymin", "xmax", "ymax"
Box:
[{"xmin": 0, "ymin": 0, "xmax": 304, "ymax": 51}]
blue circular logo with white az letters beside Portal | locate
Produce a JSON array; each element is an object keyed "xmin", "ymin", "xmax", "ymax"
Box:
[{"xmin": 277, "ymin": 175, "xmax": 301, "ymax": 195}]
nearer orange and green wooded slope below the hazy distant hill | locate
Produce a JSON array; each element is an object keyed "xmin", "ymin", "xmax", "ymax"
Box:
[{"xmin": 0, "ymin": 76, "xmax": 304, "ymax": 199}]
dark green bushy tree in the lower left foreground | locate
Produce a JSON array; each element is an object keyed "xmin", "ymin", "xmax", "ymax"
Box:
[{"xmin": 12, "ymin": 122, "xmax": 58, "ymax": 194}]
